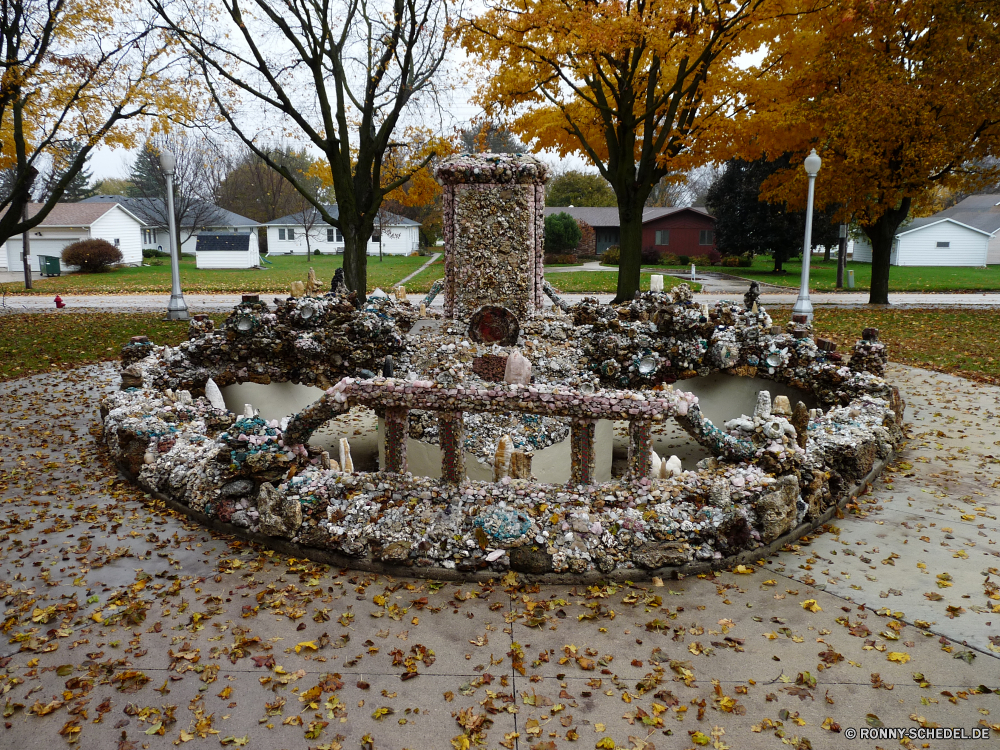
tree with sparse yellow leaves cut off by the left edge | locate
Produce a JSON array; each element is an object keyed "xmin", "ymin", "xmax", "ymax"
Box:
[{"xmin": 0, "ymin": 0, "xmax": 192, "ymax": 270}]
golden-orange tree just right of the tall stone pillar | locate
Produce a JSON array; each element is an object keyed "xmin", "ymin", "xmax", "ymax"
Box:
[{"xmin": 460, "ymin": 0, "xmax": 786, "ymax": 302}]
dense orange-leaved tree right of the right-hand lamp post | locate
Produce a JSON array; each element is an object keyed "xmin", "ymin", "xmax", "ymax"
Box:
[{"xmin": 737, "ymin": 0, "xmax": 1000, "ymax": 304}]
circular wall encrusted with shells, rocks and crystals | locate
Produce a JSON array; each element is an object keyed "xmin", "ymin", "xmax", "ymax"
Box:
[{"xmin": 102, "ymin": 287, "xmax": 903, "ymax": 580}]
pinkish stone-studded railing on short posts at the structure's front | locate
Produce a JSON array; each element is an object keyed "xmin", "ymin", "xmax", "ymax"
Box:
[{"xmin": 284, "ymin": 378, "xmax": 719, "ymax": 485}]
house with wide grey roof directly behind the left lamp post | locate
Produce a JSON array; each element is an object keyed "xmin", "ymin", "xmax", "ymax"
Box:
[{"xmin": 82, "ymin": 195, "xmax": 260, "ymax": 254}]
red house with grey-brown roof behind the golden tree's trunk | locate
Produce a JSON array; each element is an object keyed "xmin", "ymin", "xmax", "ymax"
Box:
[{"xmin": 545, "ymin": 206, "xmax": 715, "ymax": 258}]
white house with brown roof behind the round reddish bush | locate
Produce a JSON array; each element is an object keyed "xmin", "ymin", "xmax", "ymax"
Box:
[{"xmin": 0, "ymin": 203, "xmax": 143, "ymax": 273}]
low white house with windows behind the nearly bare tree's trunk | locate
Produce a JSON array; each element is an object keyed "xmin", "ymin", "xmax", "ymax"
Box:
[{"xmin": 265, "ymin": 205, "xmax": 420, "ymax": 255}]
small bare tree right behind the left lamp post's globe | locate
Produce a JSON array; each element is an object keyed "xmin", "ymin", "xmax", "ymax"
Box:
[{"xmin": 128, "ymin": 139, "xmax": 225, "ymax": 258}]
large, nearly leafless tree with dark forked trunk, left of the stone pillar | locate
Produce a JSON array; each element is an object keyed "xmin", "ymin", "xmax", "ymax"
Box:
[{"xmin": 149, "ymin": 0, "xmax": 448, "ymax": 299}]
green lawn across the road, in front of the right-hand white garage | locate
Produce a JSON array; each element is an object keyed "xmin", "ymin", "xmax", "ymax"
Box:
[{"xmin": 712, "ymin": 255, "xmax": 1000, "ymax": 292}]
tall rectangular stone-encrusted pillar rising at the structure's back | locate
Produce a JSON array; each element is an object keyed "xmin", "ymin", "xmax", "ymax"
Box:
[{"xmin": 436, "ymin": 154, "xmax": 548, "ymax": 320}]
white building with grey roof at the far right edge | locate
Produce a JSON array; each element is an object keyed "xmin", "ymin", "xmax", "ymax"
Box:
[{"xmin": 854, "ymin": 194, "xmax": 1000, "ymax": 267}]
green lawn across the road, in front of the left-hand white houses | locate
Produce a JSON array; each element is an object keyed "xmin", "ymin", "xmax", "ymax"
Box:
[{"xmin": 5, "ymin": 255, "xmax": 430, "ymax": 295}]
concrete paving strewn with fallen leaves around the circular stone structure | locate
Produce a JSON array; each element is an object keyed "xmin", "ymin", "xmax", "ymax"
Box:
[{"xmin": 0, "ymin": 364, "xmax": 1000, "ymax": 750}]
